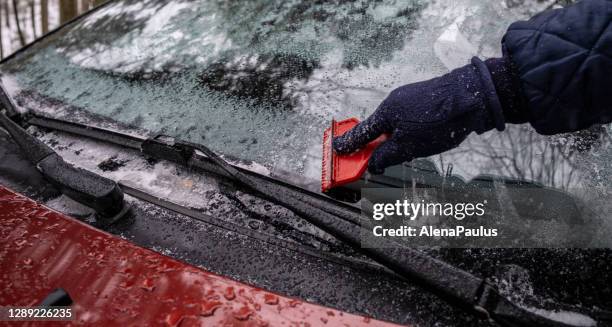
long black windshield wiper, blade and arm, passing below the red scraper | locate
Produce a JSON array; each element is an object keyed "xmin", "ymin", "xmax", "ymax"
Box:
[{"xmin": 7, "ymin": 96, "xmax": 609, "ymax": 327}]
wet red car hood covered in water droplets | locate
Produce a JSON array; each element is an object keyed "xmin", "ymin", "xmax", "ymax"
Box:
[{"xmin": 0, "ymin": 186, "xmax": 402, "ymax": 326}]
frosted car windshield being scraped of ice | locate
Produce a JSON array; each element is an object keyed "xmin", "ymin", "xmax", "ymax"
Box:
[{"xmin": 0, "ymin": 0, "xmax": 610, "ymax": 195}]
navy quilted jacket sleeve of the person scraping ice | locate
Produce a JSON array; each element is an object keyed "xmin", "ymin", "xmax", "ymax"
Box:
[{"xmin": 494, "ymin": 0, "xmax": 612, "ymax": 134}]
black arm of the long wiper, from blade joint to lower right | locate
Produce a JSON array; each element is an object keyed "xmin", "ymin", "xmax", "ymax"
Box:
[{"xmin": 185, "ymin": 144, "xmax": 596, "ymax": 327}]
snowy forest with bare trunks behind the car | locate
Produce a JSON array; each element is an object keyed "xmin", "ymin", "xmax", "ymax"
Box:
[{"xmin": 0, "ymin": 0, "xmax": 106, "ymax": 58}]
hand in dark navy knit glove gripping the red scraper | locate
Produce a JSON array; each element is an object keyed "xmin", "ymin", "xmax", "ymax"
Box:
[{"xmin": 333, "ymin": 58, "xmax": 507, "ymax": 174}]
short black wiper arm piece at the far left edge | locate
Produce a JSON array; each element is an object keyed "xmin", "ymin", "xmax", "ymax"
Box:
[{"xmin": 0, "ymin": 84, "xmax": 128, "ymax": 223}]
